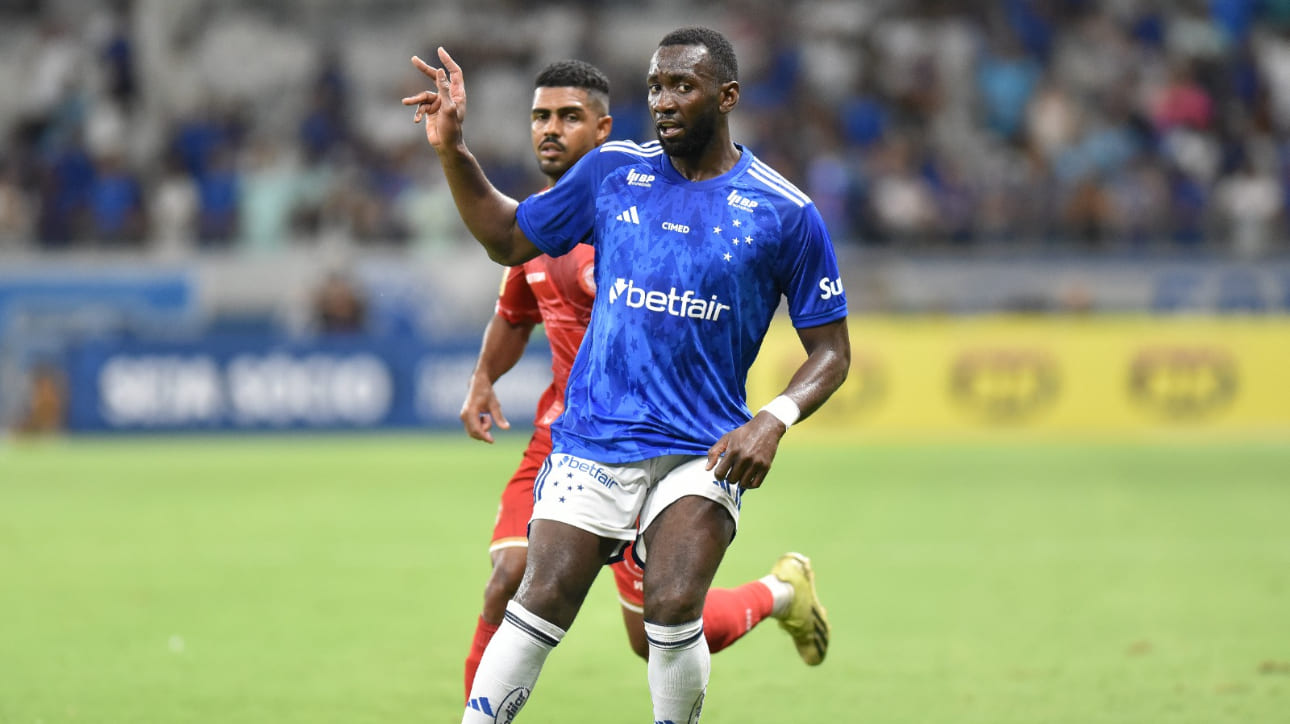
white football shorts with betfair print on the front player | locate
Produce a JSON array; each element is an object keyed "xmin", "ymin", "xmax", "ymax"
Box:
[{"xmin": 533, "ymin": 453, "xmax": 743, "ymax": 560}]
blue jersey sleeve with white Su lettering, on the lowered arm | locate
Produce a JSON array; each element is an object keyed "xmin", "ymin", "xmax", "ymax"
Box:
[{"xmin": 779, "ymin": 204, "xmax": 846, "ymax": 328}]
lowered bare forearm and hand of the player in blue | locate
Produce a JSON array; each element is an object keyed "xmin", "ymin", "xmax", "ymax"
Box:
[{"xmin": 707, "ymin": 319, "xmax": 851, "ymax": 488}]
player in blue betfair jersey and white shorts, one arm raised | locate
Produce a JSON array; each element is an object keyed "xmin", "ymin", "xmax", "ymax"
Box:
[{"xmin": 405, "ymin": 28, "xmax": 850, "ymax": 724}]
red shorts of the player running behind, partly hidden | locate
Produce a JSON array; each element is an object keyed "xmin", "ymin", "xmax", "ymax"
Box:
[{"xmin": 488, "ymin": 426, "xmax": 645, "ymax": 613}]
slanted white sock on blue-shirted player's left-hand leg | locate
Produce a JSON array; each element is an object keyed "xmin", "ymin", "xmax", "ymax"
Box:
[{"xmin": 462, "ymin": 601, "xmax": 565, "ymax": 724}]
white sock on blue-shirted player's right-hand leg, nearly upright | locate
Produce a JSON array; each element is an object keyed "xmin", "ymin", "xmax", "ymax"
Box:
[{"xmin": 645, "ymin": 618, "xmax": 712, "ymax": 724}]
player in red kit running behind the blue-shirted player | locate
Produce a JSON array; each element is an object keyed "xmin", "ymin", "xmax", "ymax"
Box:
[{"xmin": 451, "ymin": 61, "xmax": 828, "ymax": 697}]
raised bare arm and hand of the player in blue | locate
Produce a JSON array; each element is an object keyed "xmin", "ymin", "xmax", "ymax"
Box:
[{"xmin": 402, "ymin": 48, "xmax": 541, "ymax": 266}]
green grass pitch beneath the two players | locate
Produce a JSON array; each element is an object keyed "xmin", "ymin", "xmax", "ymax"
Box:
[{"xmin": 0, "ymin": 432, "xmax": 1290, "ymax": 724}]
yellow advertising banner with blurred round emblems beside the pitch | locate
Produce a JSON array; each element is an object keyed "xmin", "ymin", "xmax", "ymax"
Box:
[{"xmin": 748, "ymin": 316, "xmax": 1290, "ymax": 441}]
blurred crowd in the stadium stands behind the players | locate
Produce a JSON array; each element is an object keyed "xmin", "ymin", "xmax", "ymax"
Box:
[{"xmin": 0, "ymin": 0, "xmax": 1290, "ymax": 259}]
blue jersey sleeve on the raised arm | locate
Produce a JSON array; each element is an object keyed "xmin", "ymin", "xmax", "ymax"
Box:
[{"xmin": 516, "ymin": 148, "xmax": 601, "ymax": 257}]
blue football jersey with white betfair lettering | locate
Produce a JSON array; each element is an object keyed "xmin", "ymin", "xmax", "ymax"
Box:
[{"xmin": 519, "ymin": 141, "xmax": 846, "ymax": 463}]
